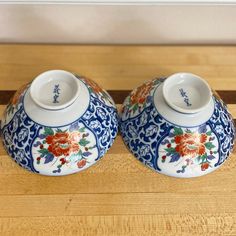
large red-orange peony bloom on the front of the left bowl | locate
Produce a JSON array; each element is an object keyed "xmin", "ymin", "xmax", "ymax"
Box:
[{"xmin": 46, "ymin": 132, "xmax": 80, "ymax": 157}]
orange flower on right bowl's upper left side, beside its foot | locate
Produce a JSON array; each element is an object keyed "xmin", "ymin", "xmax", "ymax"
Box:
[{"xmin": 130, "ymin": 82, "xmax": 152, "ymax": 105}]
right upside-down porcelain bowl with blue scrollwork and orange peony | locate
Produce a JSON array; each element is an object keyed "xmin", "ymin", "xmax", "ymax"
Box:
[{"xmin": 120, "ymin": 73, "xmax": 235, "ymax": 178}]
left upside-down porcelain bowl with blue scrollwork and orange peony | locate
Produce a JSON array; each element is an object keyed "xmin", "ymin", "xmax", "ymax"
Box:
[{"xmin": 1, "ymin": 70, "xmax": 118, "ymax": 176}]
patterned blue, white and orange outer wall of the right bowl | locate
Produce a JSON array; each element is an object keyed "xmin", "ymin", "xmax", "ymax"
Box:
[{"xmin": 120, "ymin": 80, "xmax": 235, "ymax": 177}]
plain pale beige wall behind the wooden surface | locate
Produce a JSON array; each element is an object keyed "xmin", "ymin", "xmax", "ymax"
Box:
[{"xmin": 0, "ymin": 4, "xmax": 236, "ymax": 44}]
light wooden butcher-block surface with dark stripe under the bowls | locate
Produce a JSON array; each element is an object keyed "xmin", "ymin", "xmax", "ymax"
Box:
[{"xmin": 0, "ymin": 45, "xmax": 236, "ymax": 236}]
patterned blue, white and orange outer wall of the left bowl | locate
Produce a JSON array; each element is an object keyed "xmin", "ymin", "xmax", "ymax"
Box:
[{"xmin": 2, "ymin": 77, "xmax": 118, "ymax": 175}]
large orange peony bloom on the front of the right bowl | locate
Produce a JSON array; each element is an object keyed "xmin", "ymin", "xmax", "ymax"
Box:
[{"xmin": 175, "ymin": 133, "xmax": 207, "ymax": 157}]
